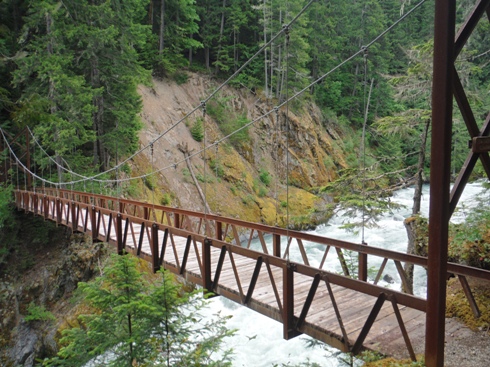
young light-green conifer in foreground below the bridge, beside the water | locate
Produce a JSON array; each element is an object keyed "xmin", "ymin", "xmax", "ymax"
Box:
[{"xmin": 43, "ymin": 255, "xmax": 233, "ymax": 367}]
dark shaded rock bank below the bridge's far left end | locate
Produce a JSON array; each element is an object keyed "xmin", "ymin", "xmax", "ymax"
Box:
[{"xmin": 0, "ymin": 212, "xmax": 107, "ymax": 367}]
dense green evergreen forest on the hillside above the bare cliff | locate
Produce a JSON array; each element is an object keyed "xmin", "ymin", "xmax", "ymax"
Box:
[{"xmin": 0, "ymin": 0, "xmax": 490, "ymax": 181}]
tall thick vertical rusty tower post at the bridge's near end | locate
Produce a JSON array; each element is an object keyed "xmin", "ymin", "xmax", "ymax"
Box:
[{"xmin": 425, "ymin": 0, "xmax": 456, "ymax": 367}]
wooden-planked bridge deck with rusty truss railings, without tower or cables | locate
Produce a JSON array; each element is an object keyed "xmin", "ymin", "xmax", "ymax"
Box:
[{"xmin": 11, "ymin": 189, "xmax": 490, "ymax": 360}]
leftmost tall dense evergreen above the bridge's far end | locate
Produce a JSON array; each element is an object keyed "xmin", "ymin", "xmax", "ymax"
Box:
[{"xmin": 13, "ymin": 0, "xmax": 95, "ymax": 178}]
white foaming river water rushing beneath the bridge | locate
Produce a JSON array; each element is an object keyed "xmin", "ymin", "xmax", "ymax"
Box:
[{"xmin": 204, "ymin": 182, "xmax": 483, "ymax": 367}]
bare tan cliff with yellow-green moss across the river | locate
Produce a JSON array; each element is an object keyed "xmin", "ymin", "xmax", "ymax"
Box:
[{"xmin": 133, "ymin": 74, "xmax": 347, "ymax": 228}]
